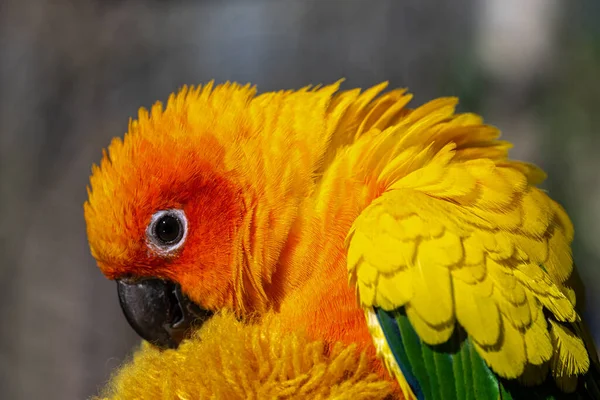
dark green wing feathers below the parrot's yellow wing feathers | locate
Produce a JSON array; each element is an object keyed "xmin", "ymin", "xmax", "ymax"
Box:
[{"xmin": 374, "ymin": 308, "xmax": 600, "ymax": 400}]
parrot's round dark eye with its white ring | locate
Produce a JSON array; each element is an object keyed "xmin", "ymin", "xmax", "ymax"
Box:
[{"xmin": 146, "ymin": 209, "xmax": 188, "ymax": 256}]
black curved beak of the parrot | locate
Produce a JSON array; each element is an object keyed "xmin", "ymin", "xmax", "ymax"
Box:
[{"xmin": 117, "ymin": 279, "xmax": 212, "ymax": 349}]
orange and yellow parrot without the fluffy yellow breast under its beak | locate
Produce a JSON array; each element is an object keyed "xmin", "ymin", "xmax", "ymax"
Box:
[{"xmin": 84, "ymin": 80, "xmax": 600, "ymax": 400}]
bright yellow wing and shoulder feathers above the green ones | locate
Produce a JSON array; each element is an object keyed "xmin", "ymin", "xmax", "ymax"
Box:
[{"xmin": 340, "ymin": 97, "xmax": 589, "ymax": 390}]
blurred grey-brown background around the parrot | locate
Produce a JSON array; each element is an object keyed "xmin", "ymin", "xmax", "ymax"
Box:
[{"xmin": 0, "ymin": 0, "xmax": 600, "ymax": 399}]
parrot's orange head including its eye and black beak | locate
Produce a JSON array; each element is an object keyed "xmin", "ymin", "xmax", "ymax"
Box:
[{"xmin": 84, "ymin": 84, "xmax": 304, "ymax": 347}]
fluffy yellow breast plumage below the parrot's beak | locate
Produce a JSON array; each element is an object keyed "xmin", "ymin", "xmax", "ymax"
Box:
[{"xmin": 96, "ymin": 314, "xmax": 392, "ymax": 400}]
